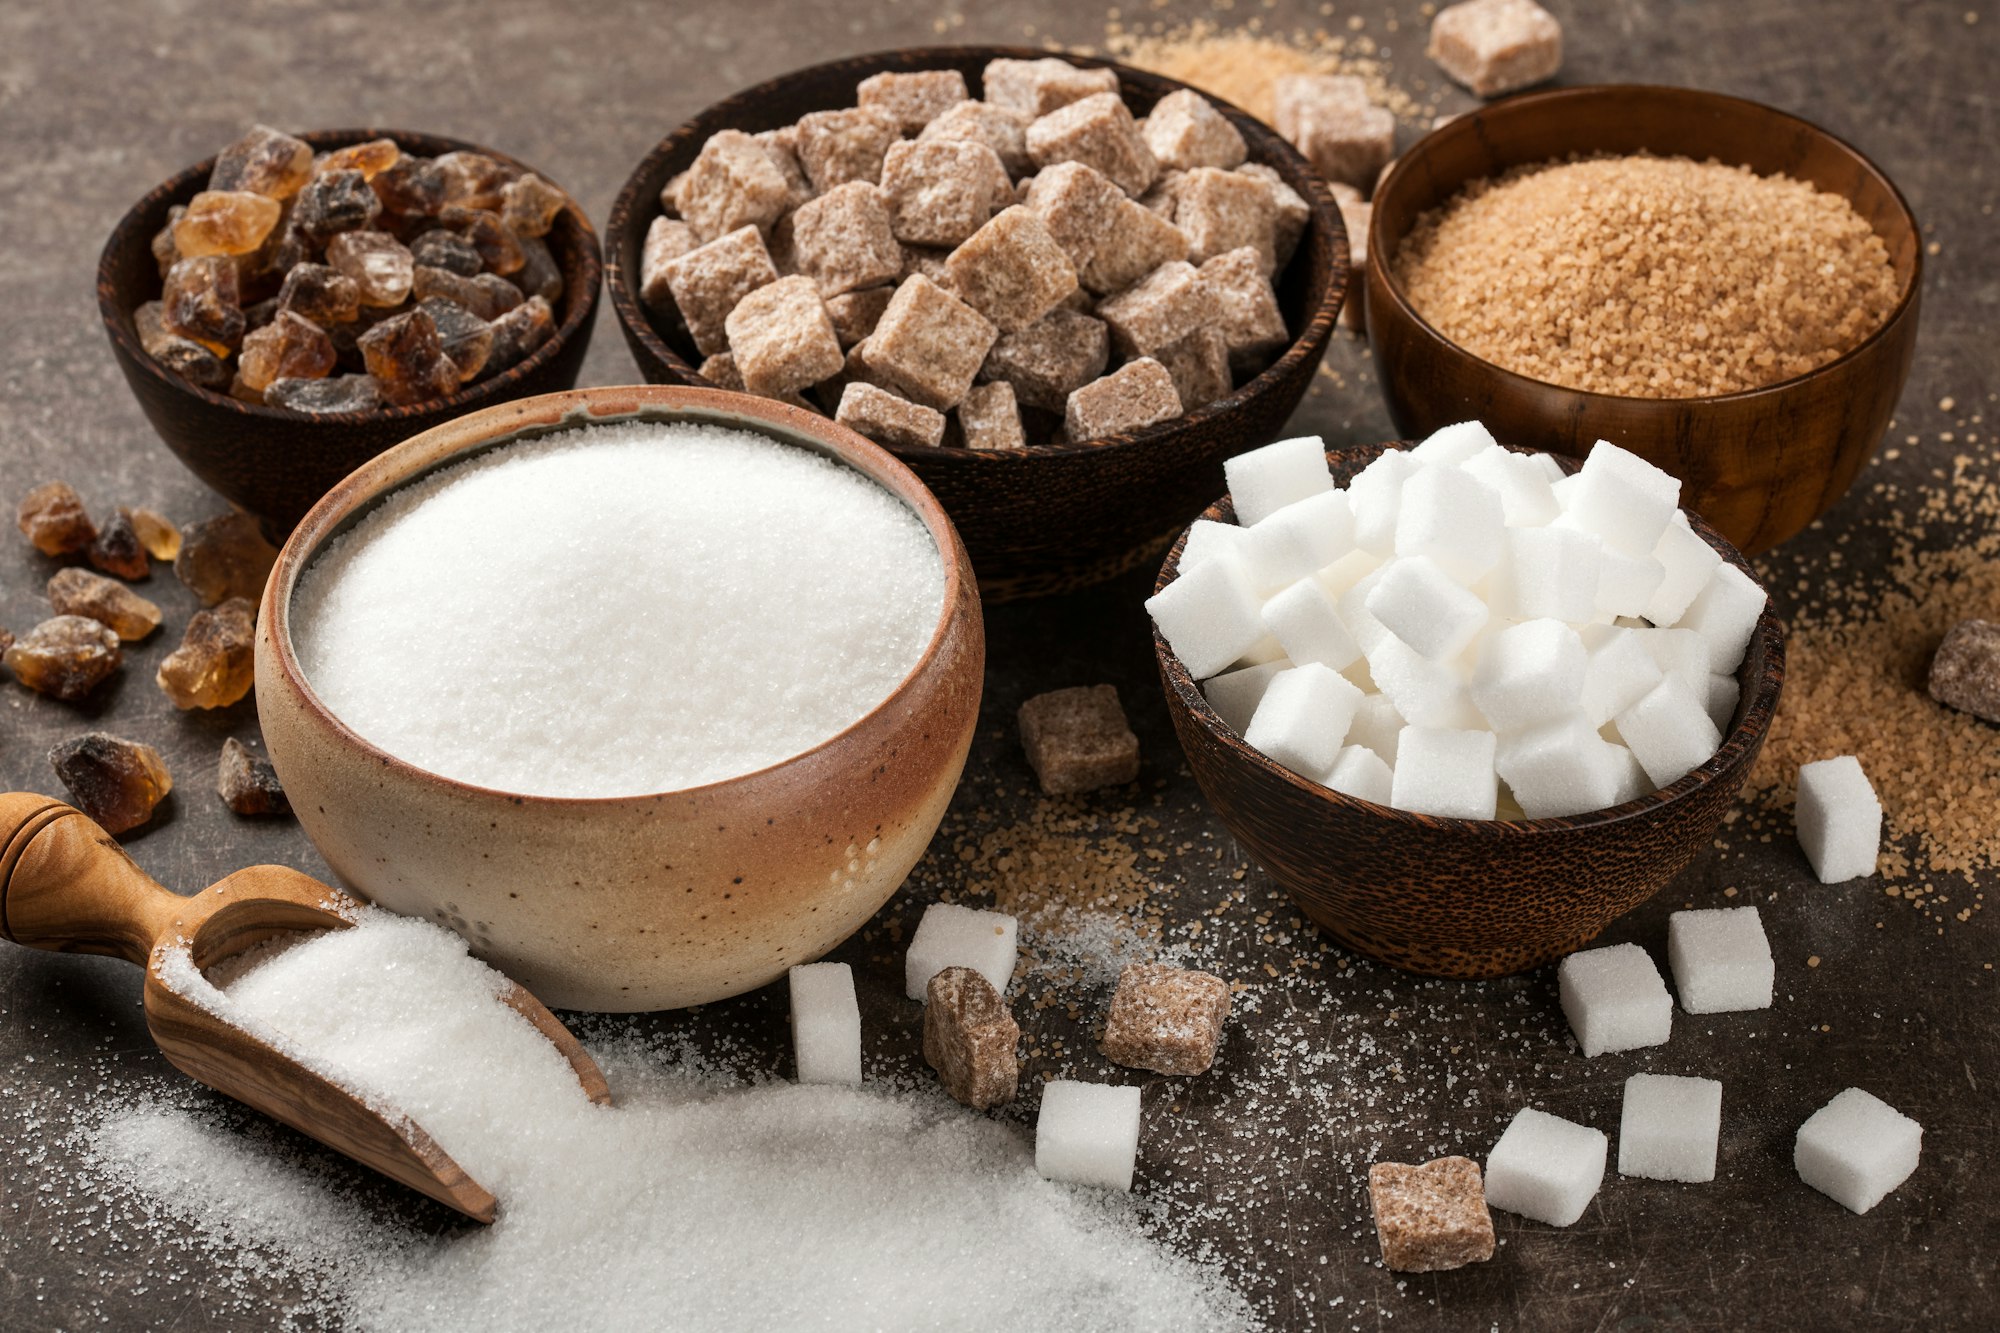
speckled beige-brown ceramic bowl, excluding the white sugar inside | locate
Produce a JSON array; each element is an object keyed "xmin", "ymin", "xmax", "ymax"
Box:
[{"xmin": 256, "ymin": 388, "xmax": 986, "ymax": 1011}]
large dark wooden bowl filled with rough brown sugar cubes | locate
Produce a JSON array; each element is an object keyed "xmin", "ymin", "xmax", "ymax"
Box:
[{"xmin": 610, "ymin": 46, "xmax": 1348, "ymax": 598}]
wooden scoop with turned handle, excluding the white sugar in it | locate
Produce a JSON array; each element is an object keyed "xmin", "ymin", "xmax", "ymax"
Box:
[{"xmin": 0, "ymin": 793, "xmax": 610, "ymax": 1223}]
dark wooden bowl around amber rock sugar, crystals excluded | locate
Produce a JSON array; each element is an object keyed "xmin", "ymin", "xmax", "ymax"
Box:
[{"xmin": 98, "ymin": 128, "xmax": 604, "ymax": 540}]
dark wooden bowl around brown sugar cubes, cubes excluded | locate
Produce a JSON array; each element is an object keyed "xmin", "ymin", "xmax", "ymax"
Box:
[{"xmin": 606, "ymin": 46, "xmax": 1348, "ymax": 600}]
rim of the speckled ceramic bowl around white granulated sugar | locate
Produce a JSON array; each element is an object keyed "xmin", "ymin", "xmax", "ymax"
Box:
[{"xmin": 258, "ymin": 384, "xmax": 984, "ymax": 809}]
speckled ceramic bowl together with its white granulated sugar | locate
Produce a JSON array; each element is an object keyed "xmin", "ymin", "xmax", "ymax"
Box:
[{"xmin": 256, "ymin": 386, "xmax": 986, "ymax": 1011}]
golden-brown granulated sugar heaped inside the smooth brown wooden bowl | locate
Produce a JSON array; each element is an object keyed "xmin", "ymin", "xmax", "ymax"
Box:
[{"xmin": 1396, "ymin": 154, "xmax": 1902, "ymax": 398}]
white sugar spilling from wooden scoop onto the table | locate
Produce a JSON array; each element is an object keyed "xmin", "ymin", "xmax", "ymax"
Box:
[{"xmin": 137, "ymin": 913, "xmax": 1252, "ymax": 1333}]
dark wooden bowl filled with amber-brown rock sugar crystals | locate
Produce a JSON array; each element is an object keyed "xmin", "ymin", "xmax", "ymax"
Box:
[{"xmin": 98, "ymin": 126, "xmax": 604, "ymax": 540}]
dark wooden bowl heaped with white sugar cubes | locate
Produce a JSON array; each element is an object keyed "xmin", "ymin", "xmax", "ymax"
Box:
[{"xmin": 1146, "ymin": 422, "xmax": 1784, "ymax": 977}]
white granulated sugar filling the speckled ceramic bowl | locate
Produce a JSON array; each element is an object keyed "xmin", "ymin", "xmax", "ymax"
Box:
[{"xmin": 292, "ymin": 422, "xmax": 944, "ymax": 797}]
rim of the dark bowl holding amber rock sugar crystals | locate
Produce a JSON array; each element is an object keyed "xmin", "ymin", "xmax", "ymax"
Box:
[{"xmin": 98, "ymin": 126, "xmax": 604, "ymax": 426}]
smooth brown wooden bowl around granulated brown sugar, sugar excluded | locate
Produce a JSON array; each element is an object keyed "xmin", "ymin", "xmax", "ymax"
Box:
[{"xmin": 1366, "ymin": 86, "xmax": 1924, "ymax": 554}]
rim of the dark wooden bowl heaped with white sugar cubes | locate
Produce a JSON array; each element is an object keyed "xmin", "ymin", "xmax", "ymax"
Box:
[{"xmin": 1150, "ymin": 440, "xmax": 1784, "ymax": 839}]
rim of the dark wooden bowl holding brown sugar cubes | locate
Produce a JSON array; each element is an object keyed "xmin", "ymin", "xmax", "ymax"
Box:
[{"xmin": 604, "ymin": 42, "xmax": 1360, "ymax": 466}]
